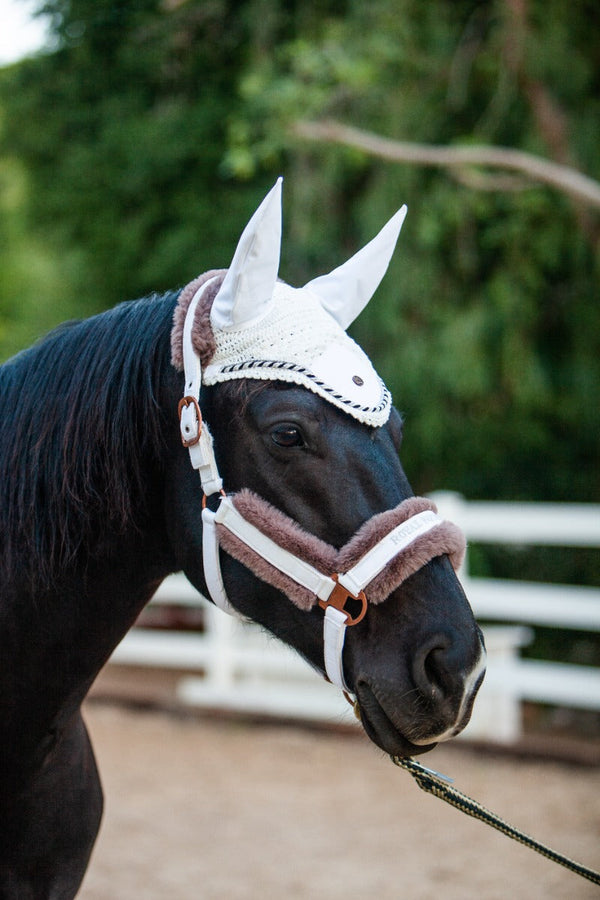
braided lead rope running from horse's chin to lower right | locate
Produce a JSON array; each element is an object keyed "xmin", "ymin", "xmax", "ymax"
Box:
[{"xmin": 390, "ymin": 756, "xmax": 600, "ymax": 885}]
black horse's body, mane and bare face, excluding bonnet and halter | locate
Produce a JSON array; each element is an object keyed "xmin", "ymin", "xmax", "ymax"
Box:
[{"xmin": 0, "ymin": 186, "xmax": 482, "ymax": 900}]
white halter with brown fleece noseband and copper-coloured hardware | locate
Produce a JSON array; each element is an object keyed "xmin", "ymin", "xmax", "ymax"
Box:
[{"xmin": 179, "ymin": 282, "xmax": 465, "ymax": 693}]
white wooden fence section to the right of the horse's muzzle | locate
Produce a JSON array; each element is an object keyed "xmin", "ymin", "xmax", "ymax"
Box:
[{"xmin": 432, "ymin": 492, "xmax": 600, "ymax": 742}]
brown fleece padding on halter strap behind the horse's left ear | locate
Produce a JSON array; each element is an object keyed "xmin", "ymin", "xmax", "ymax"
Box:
[{"xmin": 171, "ymin": 269, "xmax": 227, "ymax": 372}]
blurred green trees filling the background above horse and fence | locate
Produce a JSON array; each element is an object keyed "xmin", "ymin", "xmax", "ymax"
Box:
[{"xmin": 0, "ymin": 0, "xmax": 600, "ymax": 510}]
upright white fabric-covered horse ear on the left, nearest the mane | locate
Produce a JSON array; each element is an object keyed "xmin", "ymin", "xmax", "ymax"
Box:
[{"xmin": 210, "ymin": 178, "xmax": 282, "ymax": 329}]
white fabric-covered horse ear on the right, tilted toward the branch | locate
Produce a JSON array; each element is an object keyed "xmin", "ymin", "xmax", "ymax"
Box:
[{"xmin": 304, "ymin": 206, "xmax": 406, "ymax": 330}]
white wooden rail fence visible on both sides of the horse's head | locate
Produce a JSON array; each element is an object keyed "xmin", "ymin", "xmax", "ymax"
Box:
[{"xmin": 111, "ymin": 493, "xmax": 600, "ymax": 742}]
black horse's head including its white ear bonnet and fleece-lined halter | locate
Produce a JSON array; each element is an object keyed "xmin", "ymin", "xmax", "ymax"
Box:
[{"xmin": 166, "ymin": 181, "xmax": 485, "ymax": 756}]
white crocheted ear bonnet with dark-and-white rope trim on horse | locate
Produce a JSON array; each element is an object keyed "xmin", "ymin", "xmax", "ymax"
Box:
[{"xmin": 172, "ymin": 179, "xmax": 406, "ymax": 427}]
